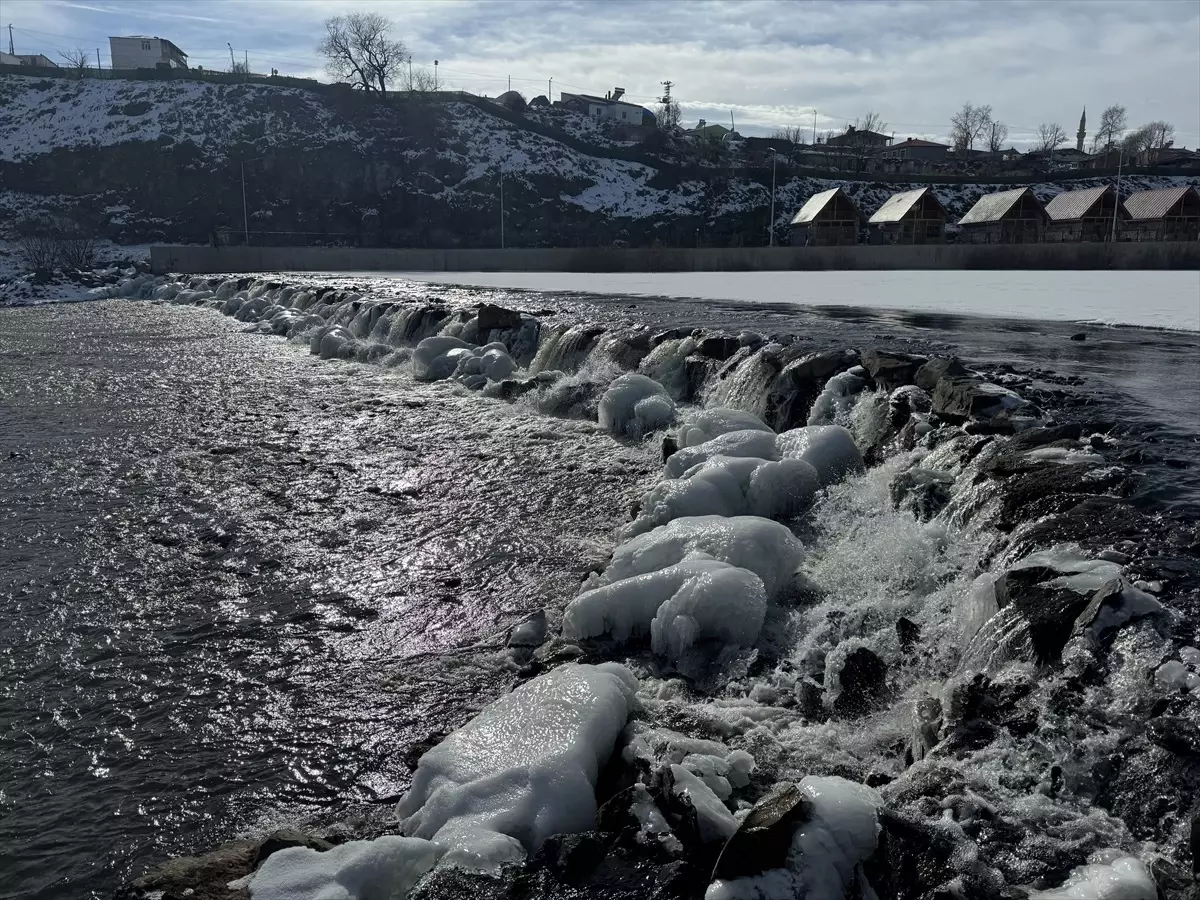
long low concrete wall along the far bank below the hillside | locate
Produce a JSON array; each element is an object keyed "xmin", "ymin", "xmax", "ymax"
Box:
[{"xmin": 150, "ymin": 241, "xmax": 1200, "ymax": 274}]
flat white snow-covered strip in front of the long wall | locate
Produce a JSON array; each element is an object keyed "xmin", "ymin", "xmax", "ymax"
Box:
[{"xmin": 404, "ymin": 271, "xmax": 1200, "ymax": 331}]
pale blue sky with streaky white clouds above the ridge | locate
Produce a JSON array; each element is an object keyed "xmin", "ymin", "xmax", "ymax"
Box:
[{"xmin": 7, "ymin": 0, "xmax": 1200, "ymax": 148}]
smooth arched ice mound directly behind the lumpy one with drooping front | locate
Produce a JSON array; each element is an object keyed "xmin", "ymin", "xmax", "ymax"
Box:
[{"xmin": 595, "ymin": 516, "xmax": 804, "ymax": 596}]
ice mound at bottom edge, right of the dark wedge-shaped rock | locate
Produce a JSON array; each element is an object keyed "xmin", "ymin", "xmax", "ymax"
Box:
[{"xmin": 704, "ymin": 775, "xmax": 883, "ymax": 900}]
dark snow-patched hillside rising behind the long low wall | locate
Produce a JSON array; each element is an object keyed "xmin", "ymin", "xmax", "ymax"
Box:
[{"xmin": 0, "ymin": 76, "xmax": 1200, "ymax": 247}]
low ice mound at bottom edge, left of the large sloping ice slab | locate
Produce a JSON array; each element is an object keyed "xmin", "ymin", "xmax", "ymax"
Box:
[{"xmin": 243, "ymin": 834, "xmax": 442, "ymax": 900}]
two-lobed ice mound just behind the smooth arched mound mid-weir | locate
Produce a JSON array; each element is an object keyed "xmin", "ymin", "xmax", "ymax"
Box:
[{"xmin": 625, "ymin": 453, "xmax": 822, "ymax": 535}]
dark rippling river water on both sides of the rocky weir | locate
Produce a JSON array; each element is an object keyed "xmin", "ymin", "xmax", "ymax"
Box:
[{"xmin": 0, "ymin": 282, "xmax": 1200, "ymax": 899}]
